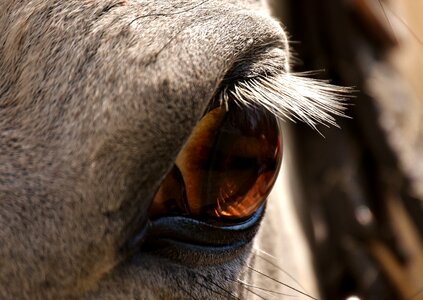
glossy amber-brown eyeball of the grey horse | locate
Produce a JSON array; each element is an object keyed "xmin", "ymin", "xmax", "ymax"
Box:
[{"xmin": 150, "ymin": 104, "xmax": 282, "ymax": 220}]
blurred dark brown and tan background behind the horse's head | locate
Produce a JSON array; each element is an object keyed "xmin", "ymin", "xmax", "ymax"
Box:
[{"xmin": 271, "ymin": 0, "xmax": 423, "ymax": 300}]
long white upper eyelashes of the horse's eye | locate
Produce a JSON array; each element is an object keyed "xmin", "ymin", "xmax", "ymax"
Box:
[{"xmin": 221, "ymin": 74, "xmax": 352, "ymax": 130}]
